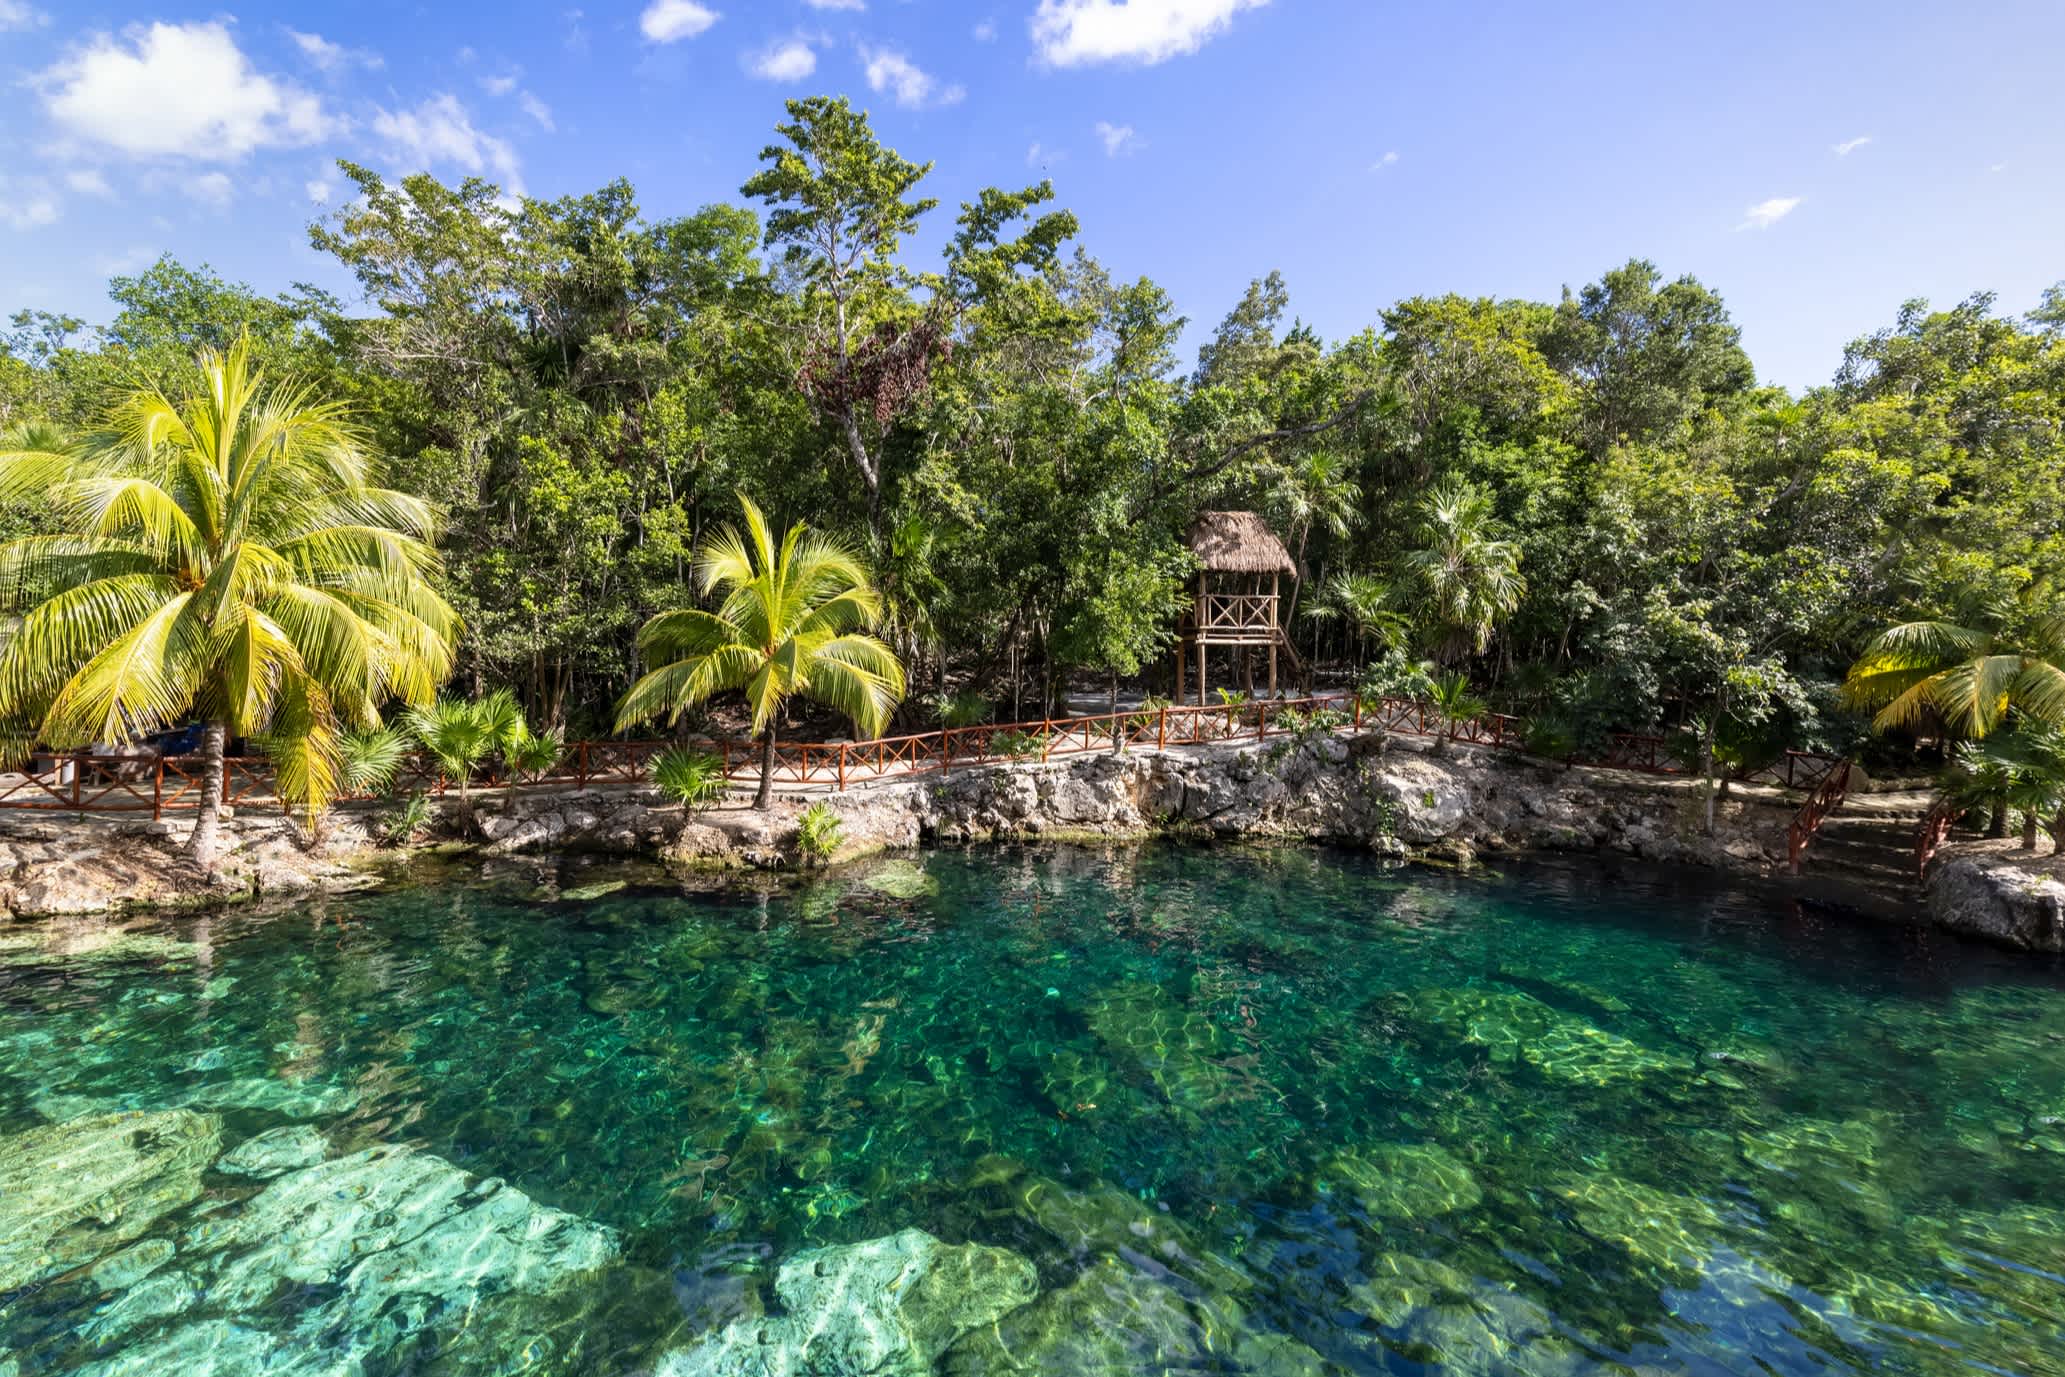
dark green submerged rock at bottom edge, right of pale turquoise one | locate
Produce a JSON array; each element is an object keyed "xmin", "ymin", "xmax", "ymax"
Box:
[{"xmin": 940, "ymin": 1257, "xmax": 1326, "ymax": 1377}]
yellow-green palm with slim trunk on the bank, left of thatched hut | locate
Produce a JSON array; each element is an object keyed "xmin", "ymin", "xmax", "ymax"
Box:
[{"xmin": 617, "ymin": 493, "xmax": 904, "ymax": 809}]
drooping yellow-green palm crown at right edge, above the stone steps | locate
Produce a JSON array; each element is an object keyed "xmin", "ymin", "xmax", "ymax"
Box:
[{"xmin": 1842, "ymin": 615, "xmax": 2065, "ymax": 739}]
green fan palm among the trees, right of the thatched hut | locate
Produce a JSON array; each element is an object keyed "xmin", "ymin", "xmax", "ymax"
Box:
[{"xmin": 1402, "ymin": 479, "xmax": 1526, "ymax": 663}]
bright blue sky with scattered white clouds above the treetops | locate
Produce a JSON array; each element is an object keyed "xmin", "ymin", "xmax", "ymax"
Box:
[{"xmin": 0, "ymin": 0, "xmax": 2065, "ymax": 388}]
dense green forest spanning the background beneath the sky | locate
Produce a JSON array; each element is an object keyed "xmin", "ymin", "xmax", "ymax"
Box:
[{"xmin": 0, "ymin": 101, "xmax": 2065, "ymax": 784}]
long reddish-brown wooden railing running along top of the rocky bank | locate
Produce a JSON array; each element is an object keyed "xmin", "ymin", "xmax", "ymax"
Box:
[{"xmin": 0, "ymin": 694, "xmax": 1848, "ymax": 818}]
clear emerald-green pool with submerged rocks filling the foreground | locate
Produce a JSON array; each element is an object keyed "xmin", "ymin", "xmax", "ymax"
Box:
[{"xmin": 0, "ymin": 846, "xmax": 2065, "ymax": 1377}]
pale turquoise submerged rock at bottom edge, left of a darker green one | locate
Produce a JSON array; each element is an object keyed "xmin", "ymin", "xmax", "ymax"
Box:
[{"xmin": 657, "ymin": 1228, "xmax": 1039, "ymax": 1377}]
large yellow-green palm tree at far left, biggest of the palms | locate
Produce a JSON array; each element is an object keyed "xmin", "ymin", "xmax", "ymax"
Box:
[{"xmin": 0, "ymin": 339, "xmax": 458, "ymax": 869}]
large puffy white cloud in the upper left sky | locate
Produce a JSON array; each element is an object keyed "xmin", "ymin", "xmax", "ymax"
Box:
[{"xmin": 33, "ymin": 23, "xmax": 332, "ymax": 161}]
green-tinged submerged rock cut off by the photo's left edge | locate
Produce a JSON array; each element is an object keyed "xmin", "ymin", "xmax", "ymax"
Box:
[{"xmin": 0, "ymin": 1109, "xmax": 221, "ymax": 1290}]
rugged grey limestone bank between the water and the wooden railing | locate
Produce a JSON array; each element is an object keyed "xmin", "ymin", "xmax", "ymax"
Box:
[{"xmin": 0, "ymin": 733, "xmax": 2065, "ymax": 952}]
